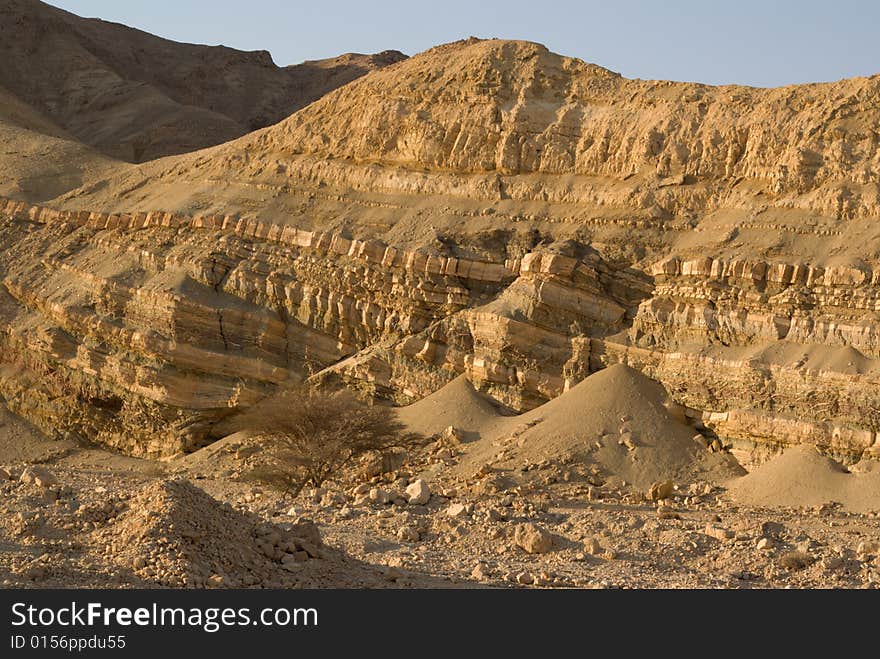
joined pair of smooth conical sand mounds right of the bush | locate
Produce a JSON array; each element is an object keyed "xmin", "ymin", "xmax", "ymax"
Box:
[{"xmin": 399, "ymin": 364, "xmax": 744, "ymax": 488}]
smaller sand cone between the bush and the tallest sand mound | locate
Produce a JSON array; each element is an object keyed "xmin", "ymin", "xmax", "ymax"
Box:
[{"xmin": 397, "ymin": 375, "xmax": 507, "ymax": 439}]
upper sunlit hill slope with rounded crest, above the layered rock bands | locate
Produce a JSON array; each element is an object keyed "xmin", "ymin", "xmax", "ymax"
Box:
[{"xmin": 53, "ymin": 39, "xmax": 880, "ymax": 263}]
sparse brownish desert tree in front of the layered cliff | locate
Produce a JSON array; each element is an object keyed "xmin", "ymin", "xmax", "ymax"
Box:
[{"xmin": 238, "ymin": 385, "xmax": 414, "ymax": 495}]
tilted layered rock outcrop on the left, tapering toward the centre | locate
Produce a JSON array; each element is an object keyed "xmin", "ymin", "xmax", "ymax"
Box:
[{"xmin": 0, "ymin": 200, "xmax": 518, "ymax": 454}]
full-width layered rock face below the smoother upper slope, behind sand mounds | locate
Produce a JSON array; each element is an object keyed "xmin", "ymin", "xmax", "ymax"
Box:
[{"xmin": 0, "ymin": 196, "xmax": 880, "ymax": 464}]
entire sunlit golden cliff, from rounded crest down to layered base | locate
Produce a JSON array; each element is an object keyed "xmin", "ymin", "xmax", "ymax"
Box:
[{"xmin": 0, "ymin": 40, "xmax": 880, "ymax": 465}]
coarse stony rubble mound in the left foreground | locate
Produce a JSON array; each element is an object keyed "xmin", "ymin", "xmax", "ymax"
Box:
[{"xmin": 106, "ymin": 480, "xmax": 323, "ymax": 587}]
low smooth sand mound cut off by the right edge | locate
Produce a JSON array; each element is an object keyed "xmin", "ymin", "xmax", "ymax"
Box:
[{"xmin": 728, "ymin": 444, "xmax": 880, "ymax": 513}]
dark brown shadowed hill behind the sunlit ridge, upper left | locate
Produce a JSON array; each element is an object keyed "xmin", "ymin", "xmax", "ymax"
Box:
[{"xmin": 0, "ymin": 0, "xmax": 404, "ymax": 162}]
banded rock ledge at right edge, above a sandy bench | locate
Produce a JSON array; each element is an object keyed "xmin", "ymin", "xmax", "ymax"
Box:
[{"xmin": 633, "ymin": 258, "xmax": 880, "ymax": 358}]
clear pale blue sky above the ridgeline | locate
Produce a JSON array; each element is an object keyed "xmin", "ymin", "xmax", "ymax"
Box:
[{"xmin": 50, "ymin": 0, "xmax": 880, "ymax": 86}]
